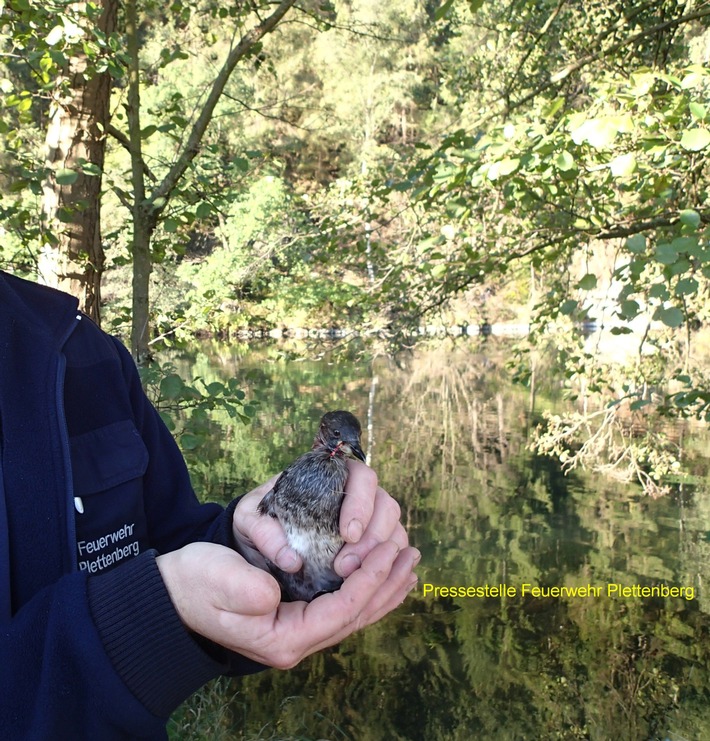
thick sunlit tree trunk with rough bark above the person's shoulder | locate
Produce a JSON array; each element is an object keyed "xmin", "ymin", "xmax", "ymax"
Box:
[{"xmin": 38, "ymin": 0, "xmax": 118, "ymax": 322}]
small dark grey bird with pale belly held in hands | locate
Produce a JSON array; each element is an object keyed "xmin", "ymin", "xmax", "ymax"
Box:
[{"xmin": 258, "ymin": 410, "xmax": 365, "ymax": 602}]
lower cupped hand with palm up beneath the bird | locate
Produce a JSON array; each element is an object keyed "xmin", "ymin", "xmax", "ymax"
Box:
[{"xmin": 156, "ymin": 540, "xmax": 419, "ymax": 669}]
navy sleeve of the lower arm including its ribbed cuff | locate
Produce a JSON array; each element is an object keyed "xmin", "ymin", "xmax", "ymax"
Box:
[{"xmin": 0, "ymin": 552, "xmax": 228, "ymax": 741}]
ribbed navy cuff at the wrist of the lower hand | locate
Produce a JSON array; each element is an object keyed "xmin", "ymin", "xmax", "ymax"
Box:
[{"xmin": 88, "ymin": 551, "xmax": 225, "ymax": 718}]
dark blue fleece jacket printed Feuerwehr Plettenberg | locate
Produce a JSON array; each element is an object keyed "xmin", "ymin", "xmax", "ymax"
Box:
[{"xmin": 0, "ymin": 273, "xmax": 256, "ymax": 741}]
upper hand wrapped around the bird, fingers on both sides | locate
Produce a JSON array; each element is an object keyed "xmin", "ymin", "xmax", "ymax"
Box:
[{"xmin": 233, "ymin": 460, "xmax": 409, "ymax": 577}]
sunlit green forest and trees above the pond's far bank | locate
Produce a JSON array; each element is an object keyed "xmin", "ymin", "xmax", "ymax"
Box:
[{"xmin": 0, "ymin": 0, "xmax": 710, "ymax": 494}]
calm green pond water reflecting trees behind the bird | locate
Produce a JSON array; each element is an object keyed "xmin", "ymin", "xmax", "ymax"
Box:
[{"xmin": 165, "ymin": 341, "xmax": 710, "ymax": 741}]
